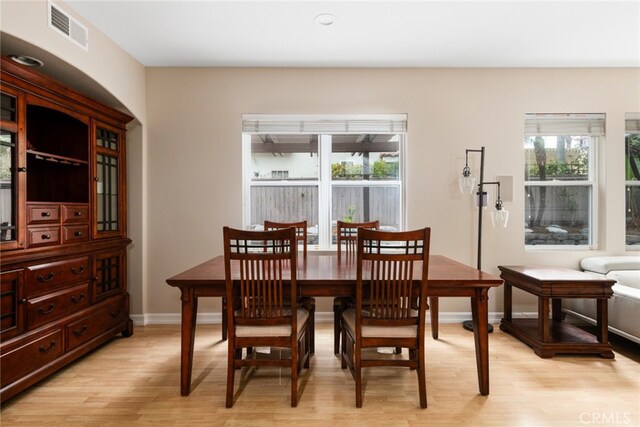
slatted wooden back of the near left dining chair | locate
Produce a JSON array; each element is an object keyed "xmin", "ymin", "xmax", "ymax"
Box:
[{"xmin": 223, "ymin": 227, "xmax": 297, "ymax": 325}]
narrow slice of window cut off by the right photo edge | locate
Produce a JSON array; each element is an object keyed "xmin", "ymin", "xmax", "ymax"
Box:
[{"xmin": 624, "ymin": 113, "xmax": 640, "ymax": 250}]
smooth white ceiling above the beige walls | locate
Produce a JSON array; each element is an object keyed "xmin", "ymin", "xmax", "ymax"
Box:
[{"xmin": 69, "ymin": 0, "xmax": 640, "ymax": 67}]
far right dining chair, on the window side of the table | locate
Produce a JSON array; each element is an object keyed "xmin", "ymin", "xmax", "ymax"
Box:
[{"xmin": 333, "ymin": 221, "xmax": 380, "ymax": 354}]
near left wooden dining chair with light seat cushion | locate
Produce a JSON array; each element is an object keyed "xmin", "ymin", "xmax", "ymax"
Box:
[{"xmin": 223, "ymin": 227, "xmax": 311, "ymax": 408}]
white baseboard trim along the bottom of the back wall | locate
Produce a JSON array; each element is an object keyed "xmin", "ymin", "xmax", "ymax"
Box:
[{"xmin": 131, "ymin": 312, "xmax": 538, "ymax": 326}]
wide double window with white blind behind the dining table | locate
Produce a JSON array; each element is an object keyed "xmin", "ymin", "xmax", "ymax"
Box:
[{"xmin": 243, "ymin": 115, "xmax": 406, "ymax": 249}]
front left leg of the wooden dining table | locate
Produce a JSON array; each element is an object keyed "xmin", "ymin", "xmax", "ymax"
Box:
[{"xmin": 180, "ymin": 288, "xmax": 198, "ymax": 396}]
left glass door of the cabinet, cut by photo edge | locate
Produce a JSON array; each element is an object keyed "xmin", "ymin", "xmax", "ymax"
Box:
[{"xmin": 0, "ymin": 88, "xmax": 26, "ymax": 250}]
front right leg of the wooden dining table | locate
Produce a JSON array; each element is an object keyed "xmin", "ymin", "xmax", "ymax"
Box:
[{"xmin": 471, "ymin": 288, "xmax": 489, "ymax": 396}]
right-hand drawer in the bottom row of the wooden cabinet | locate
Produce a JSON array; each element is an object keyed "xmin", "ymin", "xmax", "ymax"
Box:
[{"xmin": 65, "ymin": 298, "xmax": 126, "ymax": 350}]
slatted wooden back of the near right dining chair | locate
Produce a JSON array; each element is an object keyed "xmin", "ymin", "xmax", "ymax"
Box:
[{"xmin": 356, "ymin": 228, "xmax": 430, "ymax": 325}]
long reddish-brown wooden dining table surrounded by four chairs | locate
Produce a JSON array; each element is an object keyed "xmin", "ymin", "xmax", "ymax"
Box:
[{"xmin": 167, "ymin": 252, "xmax": 503, "ymax": 396}]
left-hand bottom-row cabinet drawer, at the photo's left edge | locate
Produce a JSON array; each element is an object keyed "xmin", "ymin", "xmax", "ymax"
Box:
[{"xmin": 0, "ymin": 329, "xmax": 63, "ymax": 388}]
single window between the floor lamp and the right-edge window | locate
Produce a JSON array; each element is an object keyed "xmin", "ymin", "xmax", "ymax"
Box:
[{"xmin": 524, "ymin": 114, "xmax": 605, "ymax": 249}]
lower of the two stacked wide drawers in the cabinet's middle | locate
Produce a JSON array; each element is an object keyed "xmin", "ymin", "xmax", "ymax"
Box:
[{"xmin": 27, "ymin": 283, "xmax": 89, "ymax": 329}]
